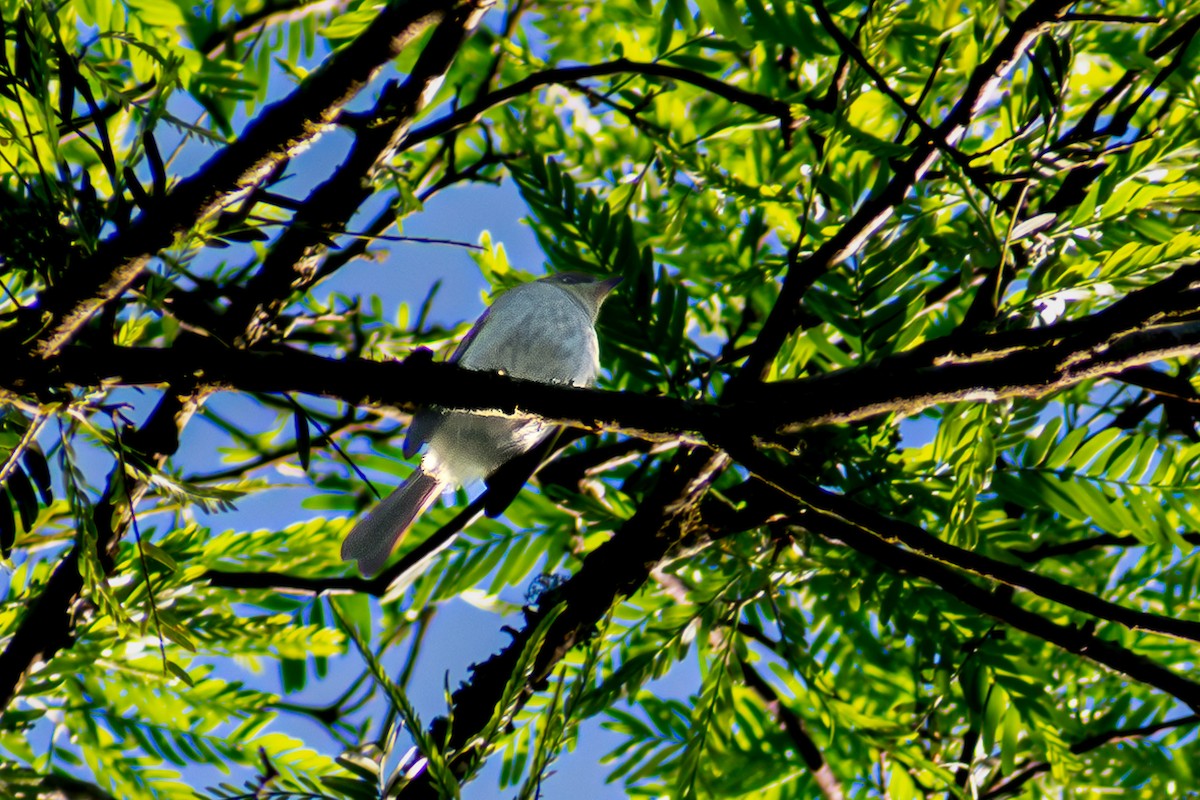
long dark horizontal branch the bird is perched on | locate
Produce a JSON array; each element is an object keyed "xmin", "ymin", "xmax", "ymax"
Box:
[{"xmin": 16, "ymin": 304, "xmax": 1200, "ymax": 439}]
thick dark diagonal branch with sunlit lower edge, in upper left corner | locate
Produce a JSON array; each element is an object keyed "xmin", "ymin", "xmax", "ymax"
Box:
[{"xmin": 26, "ymin": 0, "xmax": 462, "ymax": 357}]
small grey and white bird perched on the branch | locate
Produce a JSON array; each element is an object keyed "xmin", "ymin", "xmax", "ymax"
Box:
[{"xmin": 342, "ymin": 272, "xmax": 620, "ymax": 577}]
